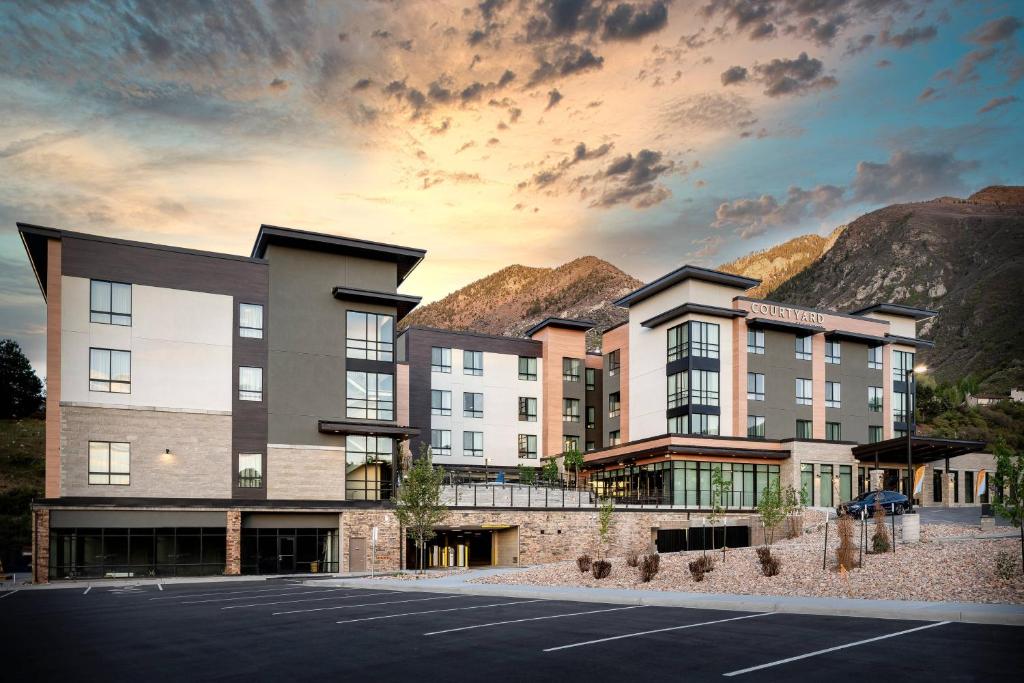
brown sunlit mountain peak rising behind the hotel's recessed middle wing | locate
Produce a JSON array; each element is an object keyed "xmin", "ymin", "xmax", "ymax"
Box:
[{"xmin": 401, "ymin": 256, "xmax": 643, "ymax": 347}]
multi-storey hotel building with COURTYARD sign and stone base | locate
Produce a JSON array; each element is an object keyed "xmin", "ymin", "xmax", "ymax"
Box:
[{"xmin": 18, "ymin": 224, "xmax": 991, "ymax": 581}]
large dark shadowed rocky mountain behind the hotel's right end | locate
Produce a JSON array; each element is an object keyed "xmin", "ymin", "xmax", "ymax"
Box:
[{"xmin": 767, "ymin": 186, "xmax": 1024, "ymax": 391}]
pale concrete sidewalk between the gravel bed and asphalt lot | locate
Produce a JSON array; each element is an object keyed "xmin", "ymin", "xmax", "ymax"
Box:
[{"xmin": 316, "ymin": 568, "xmax": 1024, "ymax": 626}]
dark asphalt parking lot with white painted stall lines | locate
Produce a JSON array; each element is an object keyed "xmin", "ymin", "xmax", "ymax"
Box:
[{"xmin": 0, "ymin": 582, "xmax": 1024, "ymax": 681}]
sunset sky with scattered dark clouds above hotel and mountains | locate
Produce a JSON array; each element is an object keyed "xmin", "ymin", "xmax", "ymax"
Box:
[{"xmin": 0, "ymin": 0, "xmax": 1024, "ymax": 376}]
